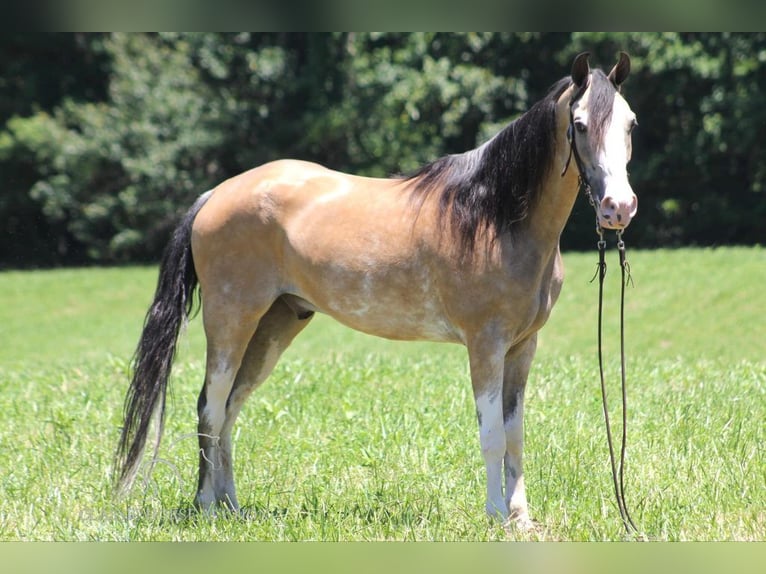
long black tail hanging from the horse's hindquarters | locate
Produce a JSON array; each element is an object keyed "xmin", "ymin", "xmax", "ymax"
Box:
[{"xmin": 115, "ymin": 192, "xmax": 210, "ymax": 498}]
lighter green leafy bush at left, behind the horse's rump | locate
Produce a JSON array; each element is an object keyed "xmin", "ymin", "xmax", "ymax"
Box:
[{"xmin": 9, "ymin": 34, "xmax": 228, "ymax": 260}]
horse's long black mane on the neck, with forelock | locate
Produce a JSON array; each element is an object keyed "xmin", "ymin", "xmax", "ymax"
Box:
[{"xmin": 407, "ymin": 70, "xmax": 615, "ymax": 254}]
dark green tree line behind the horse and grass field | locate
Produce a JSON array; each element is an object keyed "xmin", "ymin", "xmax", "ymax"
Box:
[{"xmin": 0, "ymin": 32, "xmax": 766, "ymax": 267}]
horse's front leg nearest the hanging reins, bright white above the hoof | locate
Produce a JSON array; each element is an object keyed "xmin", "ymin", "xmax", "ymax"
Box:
[{"xmin": 503, "ymin": 334, "xmax": 537, "ymax": 529}]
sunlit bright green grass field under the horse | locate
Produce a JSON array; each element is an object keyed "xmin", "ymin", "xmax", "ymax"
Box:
[{"xmin": 0, "ymin": 248, "xmax": 766, "ymax": 541}]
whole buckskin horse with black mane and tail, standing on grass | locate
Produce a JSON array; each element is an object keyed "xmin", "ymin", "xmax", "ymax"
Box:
[{"xmin": 115, "ymin": 52, "xmax": 637, "ymax": 528}]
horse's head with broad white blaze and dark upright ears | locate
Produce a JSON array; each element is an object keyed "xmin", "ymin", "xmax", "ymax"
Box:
[{"xmin": 569, "ymin": 52, "xmax": 638, "ymax": 229}]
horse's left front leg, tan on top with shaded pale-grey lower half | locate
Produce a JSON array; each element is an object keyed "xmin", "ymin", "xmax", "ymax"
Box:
[{"xmin": 468, "ymin": 337, "xmax": 508, "ymax": 521}]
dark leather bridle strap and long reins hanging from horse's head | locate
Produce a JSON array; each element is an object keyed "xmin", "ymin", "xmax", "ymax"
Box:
[{"xmin": 561, "ymin": 88, "xmax": 639, "ymax": 534}]
